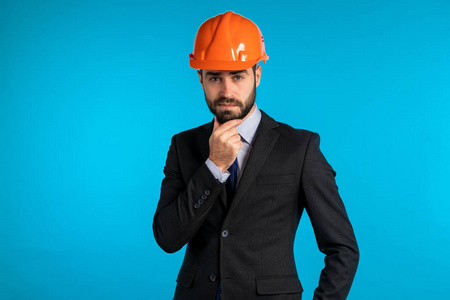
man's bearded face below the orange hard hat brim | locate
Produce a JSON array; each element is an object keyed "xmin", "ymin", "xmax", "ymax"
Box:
[{"xmin": 199, "ymin": 66, "xmax": 261, "ymax": 124}]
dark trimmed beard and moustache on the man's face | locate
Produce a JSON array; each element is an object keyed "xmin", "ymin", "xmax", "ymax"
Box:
[{"xmin": 205, "ymin": 84, "xmax": 256, "ymax": 124}]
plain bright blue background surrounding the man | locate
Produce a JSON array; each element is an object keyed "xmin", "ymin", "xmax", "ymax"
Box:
[{"xmin": 0, "ymin": 0, "xmax": 450, "ymax": 300}]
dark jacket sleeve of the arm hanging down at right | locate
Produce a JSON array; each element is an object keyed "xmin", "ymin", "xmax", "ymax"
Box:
[{"xmin": 302, "ymin": 133, "xmax": 359, "ymax": 300}]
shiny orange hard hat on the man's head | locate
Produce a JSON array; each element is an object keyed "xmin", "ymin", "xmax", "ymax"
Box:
[{"xmin": 189, "ymin": 11, "xmax": 269, "ymax": 70}]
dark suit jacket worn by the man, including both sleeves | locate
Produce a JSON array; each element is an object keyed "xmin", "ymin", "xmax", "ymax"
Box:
[{"xmin": 153, "ymin": 112, "xmax": 359, "ymax": 300}]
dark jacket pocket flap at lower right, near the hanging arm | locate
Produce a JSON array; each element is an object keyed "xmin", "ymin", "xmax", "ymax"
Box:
[{"xmin": 256, "ymin": 276, "xmax": 303, "ymax": 295}]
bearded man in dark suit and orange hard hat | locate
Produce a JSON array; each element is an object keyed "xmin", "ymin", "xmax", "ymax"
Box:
[{"xmin": 153, "ymin": 12, "xmax": 359, "ymax": 300}]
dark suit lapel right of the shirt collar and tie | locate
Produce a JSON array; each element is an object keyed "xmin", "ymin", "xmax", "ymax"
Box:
[{"xmin": 229, "ymin": 111, "xmax": 279, "ymax": 211}]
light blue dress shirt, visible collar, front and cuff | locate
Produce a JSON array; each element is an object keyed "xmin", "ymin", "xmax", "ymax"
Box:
[{"xmin": 205, "ymin": 104, "xmax": 261, "ymax": 185}]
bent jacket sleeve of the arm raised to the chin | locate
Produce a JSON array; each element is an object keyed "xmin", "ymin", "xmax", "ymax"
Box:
[{"xmin": 153, "ymin": 135, "xmax": 224, "ymax": 253}]
